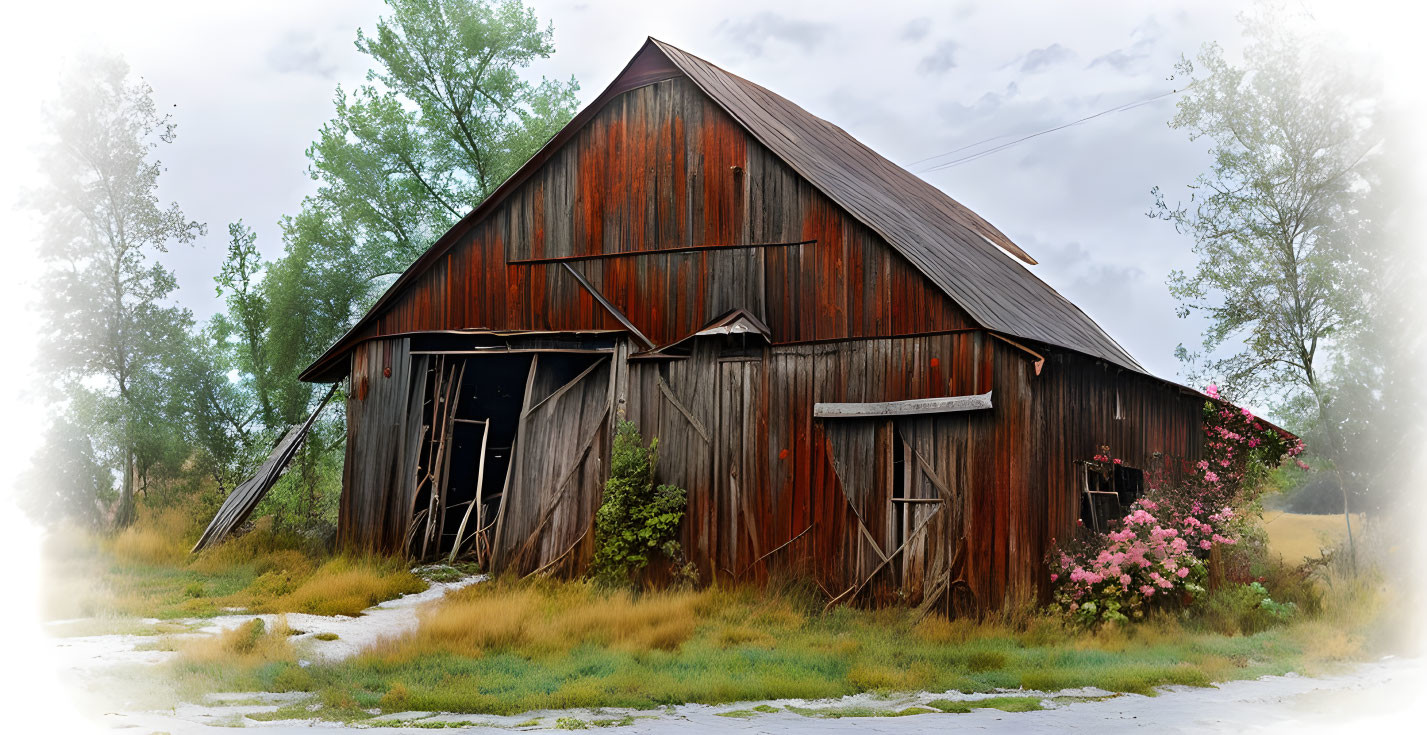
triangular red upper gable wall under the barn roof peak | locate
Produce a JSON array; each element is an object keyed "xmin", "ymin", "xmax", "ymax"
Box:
[{"xmin": 343, "ymin": 77, "xmax": 972, "ymax": 351}]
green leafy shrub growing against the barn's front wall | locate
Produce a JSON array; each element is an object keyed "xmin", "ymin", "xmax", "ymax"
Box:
[{"xmin": 591, "ymin": 421, "xmax": 686, "ymax": 585}]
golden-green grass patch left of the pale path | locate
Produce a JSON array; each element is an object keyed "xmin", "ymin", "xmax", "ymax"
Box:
[{"xmin": 43, "ymin": 507, "xmax": 427, "ymax": 622}]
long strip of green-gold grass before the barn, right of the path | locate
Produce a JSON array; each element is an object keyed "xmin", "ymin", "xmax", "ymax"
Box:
[{"xmin": 159, "ymin": 559, "xmax": 1377, "ymax": 716}]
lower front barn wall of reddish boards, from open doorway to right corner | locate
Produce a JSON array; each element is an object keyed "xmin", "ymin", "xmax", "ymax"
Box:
[{"xmin": 628, "ymin": 331, "xmax": 1010, "ymax": 610}]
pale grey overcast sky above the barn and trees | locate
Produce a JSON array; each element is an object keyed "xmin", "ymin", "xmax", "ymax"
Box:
[{"xmin": 0, "ymin": 0, "xmax": 1409, "ymax": 396}]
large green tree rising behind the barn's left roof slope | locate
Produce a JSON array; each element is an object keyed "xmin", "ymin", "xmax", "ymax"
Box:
[{"xmin": 249, "ymin": 0, "xmax": 578, "ymax": 515}]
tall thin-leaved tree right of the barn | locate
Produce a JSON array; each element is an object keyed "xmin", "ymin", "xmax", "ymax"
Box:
[{"xmin": 1152, "ymin": 6, "xmax": 1380, "ymax": 559}]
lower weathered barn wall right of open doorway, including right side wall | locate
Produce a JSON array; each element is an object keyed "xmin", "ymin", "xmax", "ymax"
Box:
[{"xmin": 629, "ymin": 333, "xmax": 1199, "ymax": 612}]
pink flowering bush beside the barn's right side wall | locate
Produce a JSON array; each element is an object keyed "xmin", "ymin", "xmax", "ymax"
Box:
[{"xmin": 1049, "ymin": 385, "xmax": 1303, "ymax": 624}]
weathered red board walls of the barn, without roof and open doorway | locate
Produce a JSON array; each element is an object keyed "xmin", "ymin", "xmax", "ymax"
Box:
[{"xmin": 323, "ymin": 78, "xmax": 1200, "ymax": 611}]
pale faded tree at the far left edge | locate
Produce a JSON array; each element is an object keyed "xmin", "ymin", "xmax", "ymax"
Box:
[{"xmin": 31, "ymin": 56, "xmax": 204, "ymax": 525}]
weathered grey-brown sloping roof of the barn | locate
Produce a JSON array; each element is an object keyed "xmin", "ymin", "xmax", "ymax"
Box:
[{"xmin": 301, "ymin": 37, "xmax": 1149, "ymax": 381}]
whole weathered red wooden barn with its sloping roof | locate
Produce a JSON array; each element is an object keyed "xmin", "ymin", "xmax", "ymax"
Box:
[{"xmin": 198, "ymin": 39, "xmax": 1204, "ymax": 611}]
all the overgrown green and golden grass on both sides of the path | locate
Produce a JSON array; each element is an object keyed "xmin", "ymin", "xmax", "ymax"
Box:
[{"xmin": 61, "ymin": 490, "xmax": 1407, "ymax": 721}]
